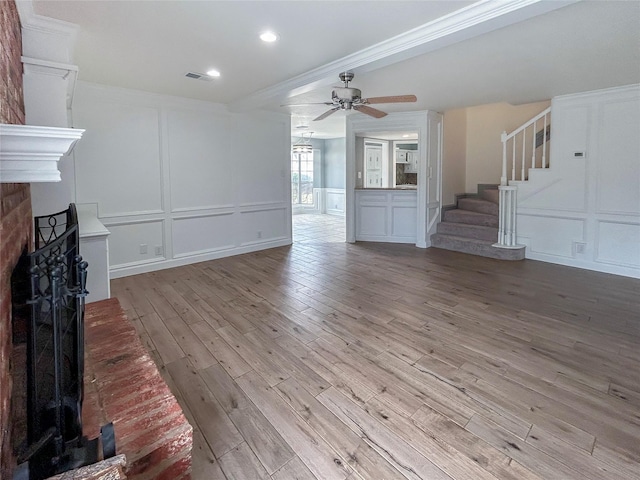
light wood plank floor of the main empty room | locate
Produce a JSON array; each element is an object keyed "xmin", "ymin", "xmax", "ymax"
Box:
[{"xmin": 112, "ymin": 236, "xmax": 640, "ymax": 480}]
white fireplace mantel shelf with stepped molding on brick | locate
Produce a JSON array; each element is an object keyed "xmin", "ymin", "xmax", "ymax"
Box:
[{"xmin": 0, "ymin": 124, "xmax": 84, "ymax": 183}]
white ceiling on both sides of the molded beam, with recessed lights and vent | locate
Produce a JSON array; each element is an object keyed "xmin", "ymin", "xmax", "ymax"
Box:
[{"xmin": 33, "ymin": 0, "xmax": 640, "ymax": 138}]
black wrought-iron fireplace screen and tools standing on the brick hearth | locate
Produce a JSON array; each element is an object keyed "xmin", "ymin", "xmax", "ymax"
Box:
[{"xmin": 12, "ymin": 204, "xmax": 115, "ymax": 480}]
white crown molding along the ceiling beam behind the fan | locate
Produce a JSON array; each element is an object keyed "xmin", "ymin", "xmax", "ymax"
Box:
[{"xmin": 229, "ymin": 0, "xmax": 580, "ymax": 111}]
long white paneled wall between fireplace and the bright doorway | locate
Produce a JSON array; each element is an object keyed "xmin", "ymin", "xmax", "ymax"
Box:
[{"xmin": 73, "ymin": 82, "xmax": 291, "ymax": 278}]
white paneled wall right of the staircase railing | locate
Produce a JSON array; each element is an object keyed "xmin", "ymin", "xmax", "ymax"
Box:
[{"xmin": 518, "ymin": 85, "xmax": 640, "ymax": 278}]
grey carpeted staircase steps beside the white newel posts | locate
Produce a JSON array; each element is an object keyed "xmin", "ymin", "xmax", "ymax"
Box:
[{"xmin": 431, "ymin": 188, "xmax": 525, "ymax": 260}]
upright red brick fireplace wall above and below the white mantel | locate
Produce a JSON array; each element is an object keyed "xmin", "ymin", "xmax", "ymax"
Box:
[{"xmin": 0, "ymin": 0, "xmax": 33, "ymax": 478}]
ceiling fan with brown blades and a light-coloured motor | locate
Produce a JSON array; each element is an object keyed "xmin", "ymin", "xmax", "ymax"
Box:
[{"xmin": 281, "ymin": 72, "xmax": 418, "ymax": 122}]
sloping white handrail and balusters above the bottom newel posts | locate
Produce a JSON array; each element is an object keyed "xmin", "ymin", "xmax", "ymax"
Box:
[{"xmin": 500, "ymin": 107, "xmax": 551, "ymax": 185}]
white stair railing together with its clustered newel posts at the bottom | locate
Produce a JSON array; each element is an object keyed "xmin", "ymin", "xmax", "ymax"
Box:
[{"xmin": 493, "ymin": 107, "xmax": 551, "ymax": 248}]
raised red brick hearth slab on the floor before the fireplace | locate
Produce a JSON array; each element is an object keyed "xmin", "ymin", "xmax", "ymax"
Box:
[{"xmin": 83, "ymin": 299, "xmax": 193, "ymax": 480}]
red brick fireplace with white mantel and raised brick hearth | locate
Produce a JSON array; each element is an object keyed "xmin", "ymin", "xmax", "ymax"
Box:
[{"xmin": 0, "ymin": 0, "xmax": 192, "ymax": 480}]
